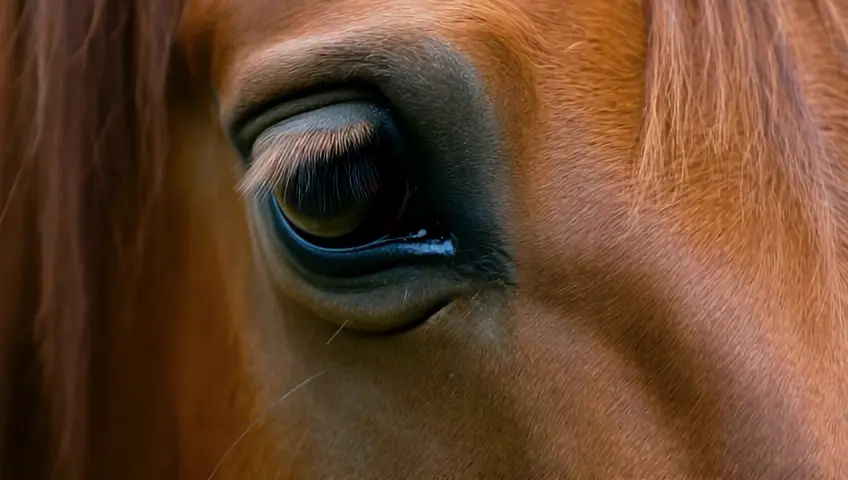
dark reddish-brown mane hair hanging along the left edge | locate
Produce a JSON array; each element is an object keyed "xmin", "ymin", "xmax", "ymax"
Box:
[{"xmin": 0, "ymin": 0, "xmax": 179, "ymax": 479}]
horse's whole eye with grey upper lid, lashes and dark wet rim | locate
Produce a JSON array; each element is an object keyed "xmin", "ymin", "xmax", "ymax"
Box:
[{"xmin": 245, "ymin": 101, "xmax": 456, "ymax": 276}]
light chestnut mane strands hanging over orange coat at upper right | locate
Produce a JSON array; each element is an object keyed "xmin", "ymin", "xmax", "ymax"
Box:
[{"xmin": 635, "ymin": 0, "xmax": 848, "ymax": 324}]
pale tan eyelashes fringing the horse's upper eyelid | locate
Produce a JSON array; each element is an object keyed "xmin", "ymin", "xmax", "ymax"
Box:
[{"xmin": 238, "ymin": 122, "xmax": 374, "ymax": 200}]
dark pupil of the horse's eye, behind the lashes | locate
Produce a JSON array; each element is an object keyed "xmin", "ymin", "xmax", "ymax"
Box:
[{"xmin": 283, "ymin": 148, "xmax": 385, "ymax": 219}]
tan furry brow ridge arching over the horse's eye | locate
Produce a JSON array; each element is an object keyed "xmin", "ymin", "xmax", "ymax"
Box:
[{"xmin": 217, "ymin": 25, "xmax": 474, "ymax": 131}]
